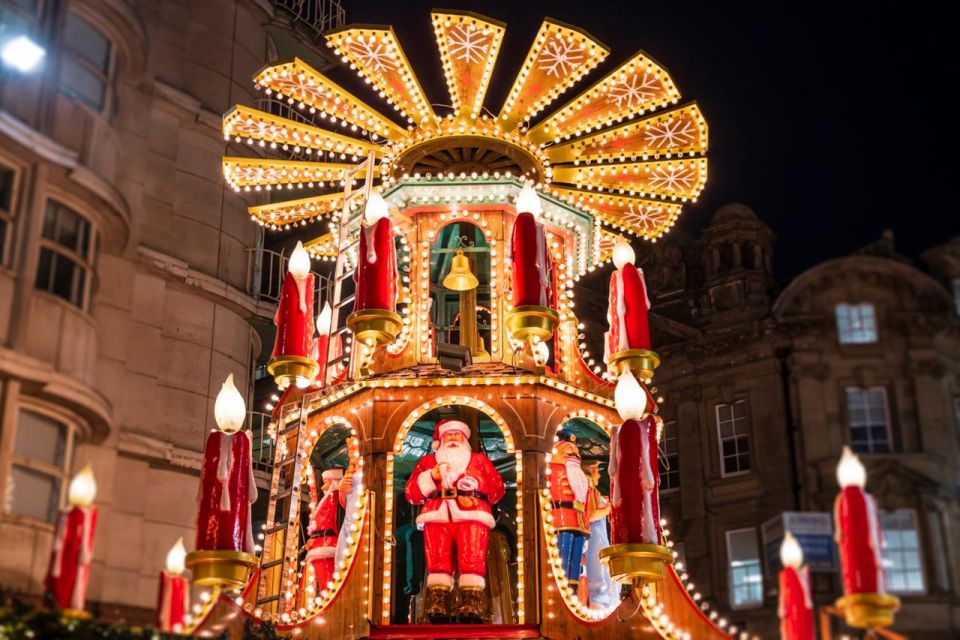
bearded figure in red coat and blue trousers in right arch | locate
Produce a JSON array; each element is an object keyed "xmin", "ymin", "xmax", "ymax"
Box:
[{"xmin": 550, "ymin": 429, "xmax": 590, "ymax": 592}]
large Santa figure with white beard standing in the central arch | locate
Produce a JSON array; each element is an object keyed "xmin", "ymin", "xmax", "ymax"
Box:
[{"xmin": 406, "ymin": 420, "xmax": 504, "ymax": 622}]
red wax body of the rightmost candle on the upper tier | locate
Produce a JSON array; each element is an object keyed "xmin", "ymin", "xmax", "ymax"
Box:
[{"xmin": 606, "ymin": 264, "xmax": 650, "ymax": 356}]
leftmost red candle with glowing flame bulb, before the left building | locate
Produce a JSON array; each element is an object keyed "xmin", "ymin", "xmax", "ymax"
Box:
[{"xmin": 44, "ymin": 465, "xmax": 97, "ymax": 617}]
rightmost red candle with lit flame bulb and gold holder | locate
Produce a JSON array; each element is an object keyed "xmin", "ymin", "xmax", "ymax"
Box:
[{"xmin": 833, "ymin": 447, "xmax": 900, "ymax": 629}]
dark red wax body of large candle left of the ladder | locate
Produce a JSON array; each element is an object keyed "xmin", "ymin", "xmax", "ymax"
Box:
[{"xmin": 196, "ymin": 431, "xmax": 257, "ymax": 553}]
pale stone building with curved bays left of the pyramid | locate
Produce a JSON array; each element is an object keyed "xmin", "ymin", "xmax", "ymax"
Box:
[{"xmin": 0, "ymin": 0, "xmax": 342, "ymax": 620}]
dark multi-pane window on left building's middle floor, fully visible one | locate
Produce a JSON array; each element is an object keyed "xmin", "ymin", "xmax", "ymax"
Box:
[{"xmin": 36, "ymin": 200, "xmax": 93, "ymax": 309}]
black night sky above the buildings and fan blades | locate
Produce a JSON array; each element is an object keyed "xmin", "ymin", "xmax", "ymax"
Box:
[{"xmin": 326, "ymin": 0, "xmax": 960, "ymax": 280}]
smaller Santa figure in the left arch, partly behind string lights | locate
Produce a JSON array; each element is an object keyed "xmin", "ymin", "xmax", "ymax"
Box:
[{"xmin": 300, "ymin": 467, "xmax": 345, "ymax": 598}]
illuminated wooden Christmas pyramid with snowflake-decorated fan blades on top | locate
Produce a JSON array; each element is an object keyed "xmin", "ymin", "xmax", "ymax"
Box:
[{"xmin": 187, "ymin": 11, "xmax": 737, "ymax": 638}]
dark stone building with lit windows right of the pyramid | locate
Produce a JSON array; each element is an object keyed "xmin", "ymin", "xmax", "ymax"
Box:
[{"xmin": 596, "ymin": 204, "xmax": 960, "ymax": 638}]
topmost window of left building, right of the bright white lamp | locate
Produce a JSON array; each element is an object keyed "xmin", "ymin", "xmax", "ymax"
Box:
[{"xmin": 60, "ymin": 11, "xmax": 111, "ymax": 113}]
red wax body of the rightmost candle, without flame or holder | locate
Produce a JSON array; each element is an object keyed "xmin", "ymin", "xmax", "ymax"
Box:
[{"xmin": 833, "ymin": 487, "xmax": 887, "ymax": 595}]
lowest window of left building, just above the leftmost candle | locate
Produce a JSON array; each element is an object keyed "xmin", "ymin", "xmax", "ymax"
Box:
[{"xmin": 8, "ymin": 409, "xmax": 68, "ymax": 523}]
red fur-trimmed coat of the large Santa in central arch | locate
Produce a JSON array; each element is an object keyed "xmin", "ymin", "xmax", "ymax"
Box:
[{"xmin": 406, "ymin": 453, "xmax": 504, "ymax": 529}]
